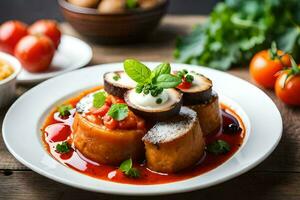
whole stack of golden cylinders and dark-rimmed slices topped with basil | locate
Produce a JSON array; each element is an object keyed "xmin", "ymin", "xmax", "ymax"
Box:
[{"xmin": 69, "ymin": 60, "xmax": 221, "ymax": 173}]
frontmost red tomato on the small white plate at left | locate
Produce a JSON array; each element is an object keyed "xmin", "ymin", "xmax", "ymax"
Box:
[{"xmin": 15, "ymin": 35, "xmax": 55, "ymax": 72}]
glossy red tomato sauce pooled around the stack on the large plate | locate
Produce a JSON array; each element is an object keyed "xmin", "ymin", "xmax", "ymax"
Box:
[{"xmin": 41, "ymin": 87, "xmax": 245, "ymax": 185}]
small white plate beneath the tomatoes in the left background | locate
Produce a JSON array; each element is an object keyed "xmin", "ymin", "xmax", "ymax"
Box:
[{"xmin": 17, "ymin": 35, "xmax": 93, "ymax": 83}]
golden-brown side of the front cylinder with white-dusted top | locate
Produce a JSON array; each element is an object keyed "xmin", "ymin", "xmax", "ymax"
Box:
[{"xmin": 144, "ymin": 108, "xmax": 205, "ymax": 173}]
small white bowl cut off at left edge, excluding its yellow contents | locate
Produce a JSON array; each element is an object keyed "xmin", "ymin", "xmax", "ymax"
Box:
[{"xmin": 0, "ymin": 52, "xmax": 22, "ymax": 108}]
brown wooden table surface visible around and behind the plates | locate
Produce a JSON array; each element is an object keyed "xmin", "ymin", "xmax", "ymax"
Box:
[{"xmin": 0, "ymin": 16, "xmax": 300, "ymax": 200}]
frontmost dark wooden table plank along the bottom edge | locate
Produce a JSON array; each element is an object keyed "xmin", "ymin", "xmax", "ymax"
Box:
[{"xmin": 0, "ymin": 171, "xmax": 300, "ymax": 200}]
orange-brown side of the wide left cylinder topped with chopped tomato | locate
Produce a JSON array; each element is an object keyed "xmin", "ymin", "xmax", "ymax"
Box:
[{"xmin": 73, "ymin": 113, "xmax": 145, "ymax": 165}]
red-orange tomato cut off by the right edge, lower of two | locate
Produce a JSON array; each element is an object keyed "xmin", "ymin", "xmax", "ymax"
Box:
[{"xmin": 275, "ymin": 71, "xmax": 300, "ymax": 106}]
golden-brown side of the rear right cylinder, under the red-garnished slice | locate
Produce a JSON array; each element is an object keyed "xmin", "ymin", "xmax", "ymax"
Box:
[{"xmin": 189, "ymin": 94, "xmax": 222, "ymax": 135}]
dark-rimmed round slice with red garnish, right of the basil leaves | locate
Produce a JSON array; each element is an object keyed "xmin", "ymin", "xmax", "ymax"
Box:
[{"xmin": 180, "ymin": 72, "xmax": 212, "ymax": 106}]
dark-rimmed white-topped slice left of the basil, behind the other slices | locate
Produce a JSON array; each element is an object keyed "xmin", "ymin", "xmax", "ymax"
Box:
[{"xmin": 103, "ymin": 71, "xmax": 136, "ymax": 98}]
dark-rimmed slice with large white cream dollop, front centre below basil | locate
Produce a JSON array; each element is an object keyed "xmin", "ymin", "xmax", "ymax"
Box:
[{"xmin": 124, "ymin": 89, "xmax": 182, "ymax": 121}]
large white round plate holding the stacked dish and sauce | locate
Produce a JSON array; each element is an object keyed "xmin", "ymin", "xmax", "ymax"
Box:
[{"xmin": 3, "ymin": 63, "xmax": 282, "ymax": 195}]
